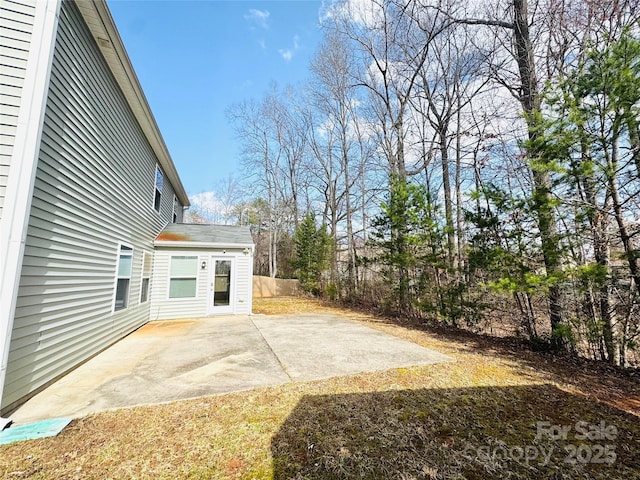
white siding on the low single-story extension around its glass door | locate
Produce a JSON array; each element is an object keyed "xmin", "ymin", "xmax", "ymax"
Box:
[{"xmin": 151, "ymin": 247, "xmax": 253, "ymax": 320}]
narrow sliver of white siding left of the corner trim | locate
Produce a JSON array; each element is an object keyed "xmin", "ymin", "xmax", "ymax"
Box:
[{"xmin": 0, "ymin": 0, "xmax": 36, "ymax": 218}]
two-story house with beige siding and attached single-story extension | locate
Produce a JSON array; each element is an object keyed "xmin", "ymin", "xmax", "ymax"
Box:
[{"xmin": 0, "ymin": 0, "xmax": 253, "ymax": 412}]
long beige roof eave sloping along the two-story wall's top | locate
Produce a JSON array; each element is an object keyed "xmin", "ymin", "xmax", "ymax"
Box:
[{"xmin": 76, "ymin": 0, "xmax": 191, "ymax": 207}]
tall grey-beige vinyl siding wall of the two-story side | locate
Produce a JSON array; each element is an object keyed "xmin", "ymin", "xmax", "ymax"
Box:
[{"xmin": 3, "ymin": 1, "xmax": 180, "ymax": 407}]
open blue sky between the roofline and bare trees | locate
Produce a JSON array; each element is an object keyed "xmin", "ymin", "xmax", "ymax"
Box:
[{"xmin": 108, "ymin": 0, "xmax": 322, "ymax": 194}]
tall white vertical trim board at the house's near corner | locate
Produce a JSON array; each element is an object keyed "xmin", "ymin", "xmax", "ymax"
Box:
[{"xmin": 0, "ymin": 0, "xmax": 61, "ymax": 412}]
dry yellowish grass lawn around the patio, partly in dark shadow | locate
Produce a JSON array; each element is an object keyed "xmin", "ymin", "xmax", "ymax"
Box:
[{"xmin": 0, "ymin": 298, "xmax": 640, "ymax": 480}]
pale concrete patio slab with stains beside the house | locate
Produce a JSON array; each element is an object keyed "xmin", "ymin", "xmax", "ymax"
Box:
[{"xmin": 10, "ymin": 314, "xmax": 451, "ymax": 425}]
